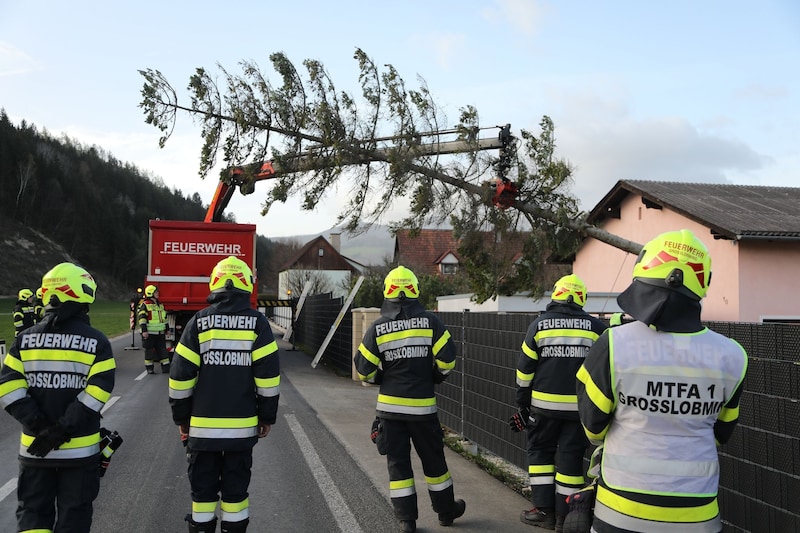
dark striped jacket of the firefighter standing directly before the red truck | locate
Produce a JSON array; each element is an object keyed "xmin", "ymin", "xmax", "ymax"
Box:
[{"xmin": 169, "ymin": 290, "xmax": 281, "ymax": 451}]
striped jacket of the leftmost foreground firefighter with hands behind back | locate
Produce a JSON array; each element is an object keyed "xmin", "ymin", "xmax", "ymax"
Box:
[{"xmin": 0, "ymin": 302, "xmax": 116, "ymax": 467}]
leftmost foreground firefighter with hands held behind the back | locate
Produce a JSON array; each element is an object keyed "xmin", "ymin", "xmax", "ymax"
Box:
[{"xmin": 0, "ymin": 263, "xmax": 116, "ymax": 532}]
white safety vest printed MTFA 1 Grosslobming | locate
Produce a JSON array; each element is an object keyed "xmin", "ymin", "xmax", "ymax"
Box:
[{"xmin": 601, "ymin": 322, "xmax": 747, "ymax": 531}]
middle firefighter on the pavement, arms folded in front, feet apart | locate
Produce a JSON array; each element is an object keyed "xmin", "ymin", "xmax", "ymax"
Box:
[{"xmin": 354, "ymin": 266, "xmax": 466, "ymax": 532}]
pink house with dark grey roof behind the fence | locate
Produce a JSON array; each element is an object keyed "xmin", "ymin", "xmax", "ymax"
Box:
[{"xmin": 573, "ymin": 180, "xmax": 800, "ymax": 322}]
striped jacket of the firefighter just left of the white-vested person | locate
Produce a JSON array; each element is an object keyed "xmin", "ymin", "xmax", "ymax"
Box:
[{"xmin": 516, "ymin": 301, "xmax": 606, "ymax": 420}]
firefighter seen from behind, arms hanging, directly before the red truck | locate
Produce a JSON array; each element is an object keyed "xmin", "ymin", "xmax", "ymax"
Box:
[{"xmin": 169, "ymin": 257, "xmax": 280, "ymax": 533}]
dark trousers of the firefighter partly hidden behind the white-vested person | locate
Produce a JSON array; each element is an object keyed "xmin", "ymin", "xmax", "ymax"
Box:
[{"xmin": 527, "ymin": 414, "xmax": 589, "ymax": 515}]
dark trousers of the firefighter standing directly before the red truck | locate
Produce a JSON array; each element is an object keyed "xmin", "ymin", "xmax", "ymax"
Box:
[{"xmin": 189, "ymin": 448, "xmax": 253, "ymax": 524}]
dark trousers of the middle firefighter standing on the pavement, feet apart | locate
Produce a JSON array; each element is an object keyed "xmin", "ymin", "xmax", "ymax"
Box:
[{"xmin": 381, "ymin": 417, "xmax": 454, "ymax": 520}]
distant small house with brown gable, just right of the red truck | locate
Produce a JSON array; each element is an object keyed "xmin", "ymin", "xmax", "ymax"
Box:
[{"xmin": 278, "ymin": 233, "xmax": 366, "ymax": 298}]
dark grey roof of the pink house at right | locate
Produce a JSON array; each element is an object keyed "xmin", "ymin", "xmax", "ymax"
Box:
[{"xmin": 587, "ymin": 180, "xmax": 800, "ymax": 240}]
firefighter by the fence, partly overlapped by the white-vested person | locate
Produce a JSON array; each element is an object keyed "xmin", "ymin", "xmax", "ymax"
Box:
[{"xmin": 509, "ymin": 274, "xmax": 606, "ymax": 531}]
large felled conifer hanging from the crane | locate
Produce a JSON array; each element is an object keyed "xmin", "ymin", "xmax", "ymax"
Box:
[{"xmin": 139, "ymin": 49, "xmax": 641, "ymax": 301}]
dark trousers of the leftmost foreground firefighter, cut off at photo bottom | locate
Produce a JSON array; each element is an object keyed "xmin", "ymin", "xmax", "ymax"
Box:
[{"xmin": 17, "ymin": 462, "xmax": 100, "ymax": 533}]
